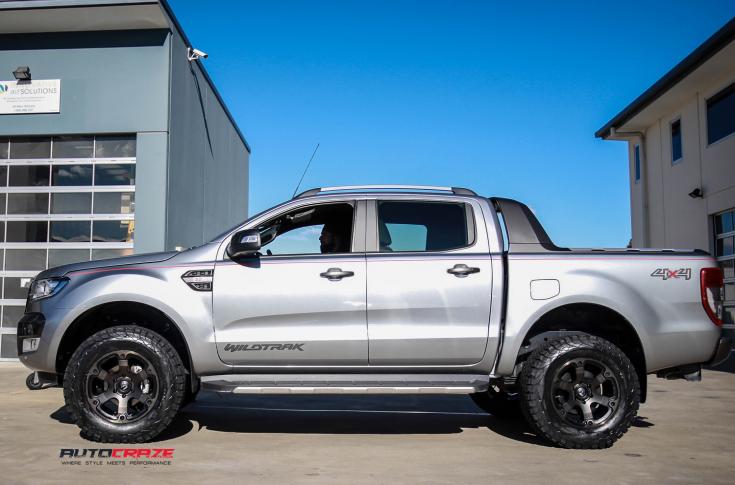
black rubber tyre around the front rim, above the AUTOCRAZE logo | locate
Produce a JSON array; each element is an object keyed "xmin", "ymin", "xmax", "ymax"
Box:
[{"xmin": 64, "ymin": 325, "xmax": 187, "ymax": 443}]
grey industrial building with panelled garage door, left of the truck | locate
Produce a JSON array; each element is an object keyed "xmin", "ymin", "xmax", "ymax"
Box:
[{"xmin": 0, "ymin": 0, "xmax": 250, "ymax": 360}]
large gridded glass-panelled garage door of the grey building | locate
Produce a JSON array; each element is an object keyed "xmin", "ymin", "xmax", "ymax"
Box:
[{"xmin": 0, "ymin": 134, "xmax": 137, "ymax": 360}]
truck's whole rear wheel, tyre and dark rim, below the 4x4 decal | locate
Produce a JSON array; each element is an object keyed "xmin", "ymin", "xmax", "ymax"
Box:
[{"xmin": 520, "ymin": 335, "xmax": 640, "ymax": 449}]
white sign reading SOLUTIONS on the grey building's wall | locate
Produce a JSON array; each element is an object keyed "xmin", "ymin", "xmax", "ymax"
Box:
[{"xmin": 0, "ymin": 79, "xmax": 61, "ymax": 115}]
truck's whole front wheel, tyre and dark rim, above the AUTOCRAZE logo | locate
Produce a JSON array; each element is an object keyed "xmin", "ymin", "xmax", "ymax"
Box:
[{"xmin": 64, "ymin": 325, "xmax": 186, "ymax": 443}]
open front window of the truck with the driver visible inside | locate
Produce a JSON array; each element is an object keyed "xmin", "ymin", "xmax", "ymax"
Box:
[{"xmin": 258, "ymin": 203, "xmax": 354, "ymax": 256}]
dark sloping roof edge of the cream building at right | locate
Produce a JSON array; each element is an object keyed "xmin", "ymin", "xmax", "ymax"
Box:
[{"xmin": 595, "ymin": 17, "xmax": 735, "ymax": 139}]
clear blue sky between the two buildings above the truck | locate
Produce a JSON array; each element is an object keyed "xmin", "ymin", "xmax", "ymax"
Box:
[{"xmin": 170, "ymin": 0, "xmax": 735, "ymax": 247}]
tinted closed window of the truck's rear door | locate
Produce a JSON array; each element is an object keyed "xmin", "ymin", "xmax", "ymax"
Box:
[{"xmin": 378, "ymin": 201, "xmax": 474, "ymax": 253}]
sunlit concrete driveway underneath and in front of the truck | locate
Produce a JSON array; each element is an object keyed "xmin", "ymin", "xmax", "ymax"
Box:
[{"xmin": 0, "ymin": 363, "xmax": 735, "ymax": 484}]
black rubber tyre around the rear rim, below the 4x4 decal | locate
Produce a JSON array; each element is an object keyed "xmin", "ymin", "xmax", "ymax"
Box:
[{"xmin": 520, "ymin": 335, "xmax": 641, "ymax": 449}]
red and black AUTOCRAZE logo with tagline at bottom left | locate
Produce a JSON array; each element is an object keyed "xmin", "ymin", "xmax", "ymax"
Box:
[{"xmin": 59, "ymin": 448, "xmax": 174, "ymax": 466}]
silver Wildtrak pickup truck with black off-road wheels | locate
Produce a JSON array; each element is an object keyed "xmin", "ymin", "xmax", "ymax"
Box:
[{"xmin": 18, "ymin": 186, "xmax": 731, "ymax": 448}]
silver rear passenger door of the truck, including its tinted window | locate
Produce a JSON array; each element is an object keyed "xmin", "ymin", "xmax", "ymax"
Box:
[{"xmin": 367, "ymin": 199, "xmax": 492, "ymax": 365}]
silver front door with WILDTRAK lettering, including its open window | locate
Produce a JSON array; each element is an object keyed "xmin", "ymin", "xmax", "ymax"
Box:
[{"xmin": 213, "ymin": 202, "xmax": 368, "ymax": 366}]
